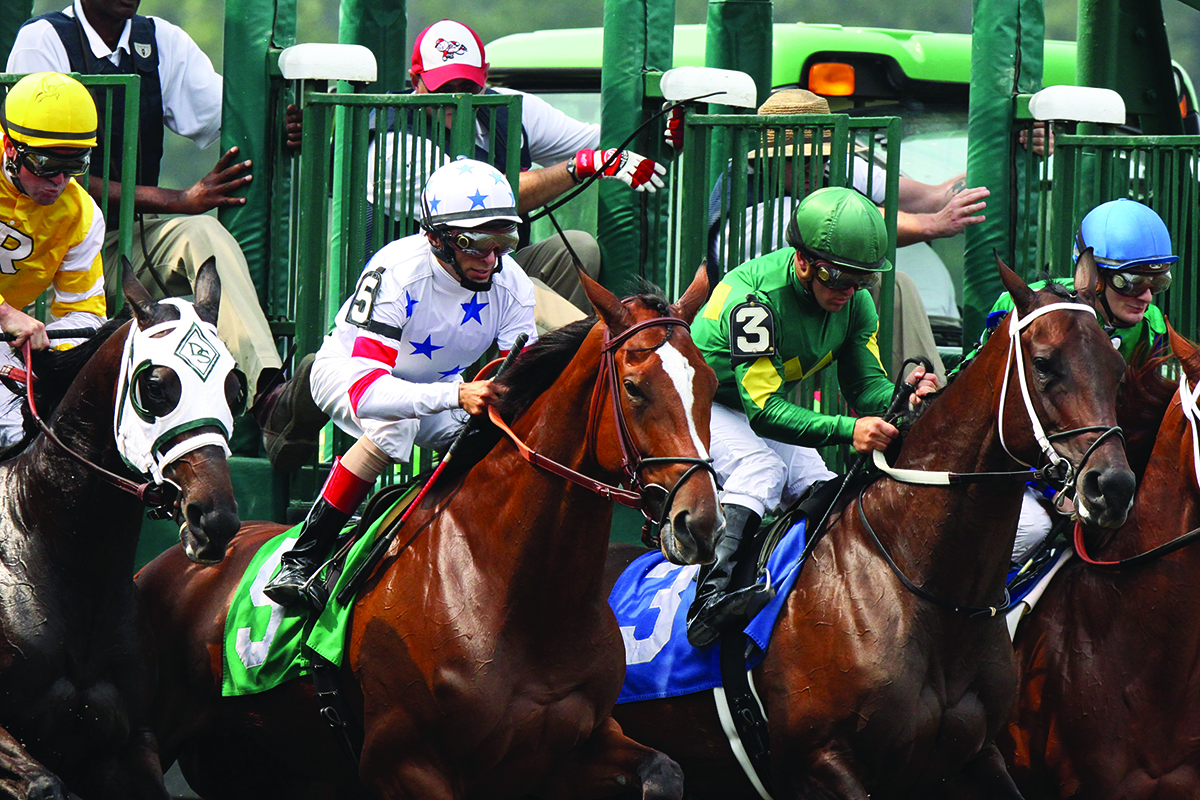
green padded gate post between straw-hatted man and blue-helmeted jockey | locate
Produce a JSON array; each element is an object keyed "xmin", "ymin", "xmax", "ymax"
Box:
[{"xmin": 962, "ymin": 0, "xmax": 1045, "ymax": 353}]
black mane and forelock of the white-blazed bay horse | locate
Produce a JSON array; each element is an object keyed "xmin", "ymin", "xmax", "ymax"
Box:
[{"xmin": 443, "ymin": 289, "xmax": 671, "ymax": 486}]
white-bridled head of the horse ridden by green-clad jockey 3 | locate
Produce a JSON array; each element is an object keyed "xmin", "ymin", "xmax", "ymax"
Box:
[{"xmin": 996, "ymin": 248, "xmax": 1135, "ymax": 528}]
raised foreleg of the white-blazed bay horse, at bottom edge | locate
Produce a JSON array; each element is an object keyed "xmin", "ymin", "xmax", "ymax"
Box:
[{"xmin": 536, "ymin": 716, "xmax": 683, "ymax": 800}]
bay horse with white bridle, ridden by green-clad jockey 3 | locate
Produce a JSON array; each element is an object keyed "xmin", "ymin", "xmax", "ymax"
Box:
[{"xmin": 608, "ymin": 254, "xmax": 1134, "ymax": 800}]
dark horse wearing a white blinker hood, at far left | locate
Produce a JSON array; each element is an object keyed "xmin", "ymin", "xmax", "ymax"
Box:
[{"xmin": 0, "ymin": 264, "xmax": 242, "ymax": 800}]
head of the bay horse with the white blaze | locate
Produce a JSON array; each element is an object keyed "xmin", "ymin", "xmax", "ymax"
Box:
[{"xmin": 580, "ymin": 267, "xmax": 724, "ymax": 564}]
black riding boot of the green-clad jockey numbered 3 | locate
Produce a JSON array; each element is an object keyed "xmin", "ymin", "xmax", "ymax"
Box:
[{"xmin": 688, "ymin": 505, "xmax": 775, "ymax": 648}]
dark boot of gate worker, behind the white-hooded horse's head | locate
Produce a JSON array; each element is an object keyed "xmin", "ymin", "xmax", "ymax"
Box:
[{"xmin": 250, "ymin": 354, "xmax": 329, "ymax": 473}]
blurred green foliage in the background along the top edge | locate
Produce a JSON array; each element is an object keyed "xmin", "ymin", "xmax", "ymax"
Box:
[{"xmin": 25, "ymin": 0, "xmax": 1200, "ymax": 186}]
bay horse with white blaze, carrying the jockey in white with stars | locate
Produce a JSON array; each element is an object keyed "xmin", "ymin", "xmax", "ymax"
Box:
[{"xmin": 138, "ymin": 269, "xmax": 724, "ymax": 800}]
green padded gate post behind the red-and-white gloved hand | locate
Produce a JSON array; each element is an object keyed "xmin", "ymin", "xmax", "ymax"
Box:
[{"xmin": 596, "ymin": 0, "xmax": 674, "ymax": 294}]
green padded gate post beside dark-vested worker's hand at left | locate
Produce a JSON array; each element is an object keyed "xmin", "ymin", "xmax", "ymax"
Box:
[{"xmin": 212, "ymin": 0, "xmax": 296, "ymax": 301}]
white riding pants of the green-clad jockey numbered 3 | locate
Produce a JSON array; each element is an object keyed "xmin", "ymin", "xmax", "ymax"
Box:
[{"xmin": 710, "ymin": 403, "xmax": 834, "ymax": 517}]
